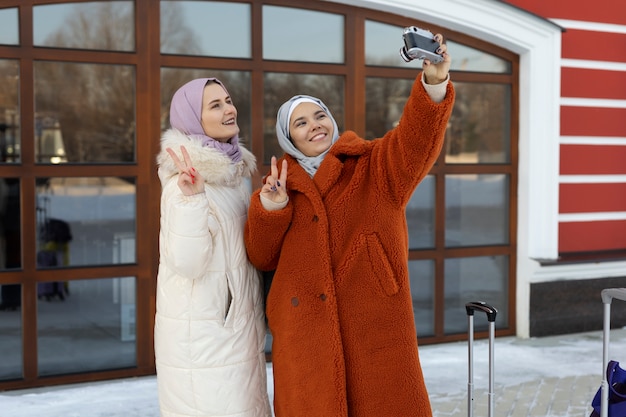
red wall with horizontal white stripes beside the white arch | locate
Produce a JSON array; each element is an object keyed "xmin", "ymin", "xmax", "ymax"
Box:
[{"xmin": 508, "ymin": 0, "xmax": 626, "ymax": 254}]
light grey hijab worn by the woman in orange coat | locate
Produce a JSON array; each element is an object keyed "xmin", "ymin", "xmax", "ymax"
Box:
[{"xmin": 276, "ymin": 94, "xmax": 339, "ymax": 177}]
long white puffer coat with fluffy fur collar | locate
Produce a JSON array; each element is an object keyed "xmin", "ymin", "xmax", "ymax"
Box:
[{"xmin": 154, "ymin": 129, "xmax": 271, "ymax": 417}]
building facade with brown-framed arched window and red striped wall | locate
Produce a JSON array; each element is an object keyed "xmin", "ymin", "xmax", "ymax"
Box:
[{"xmin": 0, "ymin": 0, "xmax": 626, "ymax": 390}]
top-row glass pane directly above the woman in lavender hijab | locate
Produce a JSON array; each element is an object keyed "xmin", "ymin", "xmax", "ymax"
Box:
[{"xmin": 161, "ymin": 1, "xmax": 252, "ymax": 58}]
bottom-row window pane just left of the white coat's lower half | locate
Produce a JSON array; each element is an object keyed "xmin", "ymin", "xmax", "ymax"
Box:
[{"xmin": 37, "ymin": 277, "xmax": 136, "ymax": 376}]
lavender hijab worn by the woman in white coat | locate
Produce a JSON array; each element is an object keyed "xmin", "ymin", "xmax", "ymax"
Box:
[{"xmin": 170, "ymin": 78, "xmax": 241, "ymax": 162}]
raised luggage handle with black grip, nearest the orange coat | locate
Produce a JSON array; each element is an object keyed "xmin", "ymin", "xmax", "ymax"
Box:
[{"xmin": 465, "ymin": 301, "xmax": 498, "ymax": 417}]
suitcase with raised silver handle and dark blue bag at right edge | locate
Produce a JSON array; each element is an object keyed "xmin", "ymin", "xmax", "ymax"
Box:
[{"xmin": 591, "ymin": 288, "xmax": 626, "ymax": 417}]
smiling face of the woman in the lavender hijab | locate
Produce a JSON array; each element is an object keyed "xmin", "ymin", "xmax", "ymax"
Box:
[{"xmin": 201, "ymin": 83, "xmax": 239, "ymax": 142}]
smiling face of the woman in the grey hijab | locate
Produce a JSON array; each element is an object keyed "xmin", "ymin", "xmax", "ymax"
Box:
[{"xmin": 289, "ymin": 102, "xmax": 334, "ymax": 156}]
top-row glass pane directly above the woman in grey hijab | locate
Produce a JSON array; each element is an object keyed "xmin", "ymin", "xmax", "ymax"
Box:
[{"xmin": 263, "ymin": 6, "xmax": 344, "ymax": 64}]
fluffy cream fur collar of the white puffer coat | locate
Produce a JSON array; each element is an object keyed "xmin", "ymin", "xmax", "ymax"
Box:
[{"xmin": 157, "ymin": 129, "xmax": 256, "ymax": 186}]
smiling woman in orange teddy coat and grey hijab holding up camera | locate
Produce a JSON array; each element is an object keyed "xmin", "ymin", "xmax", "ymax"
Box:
[{"xmin": 245, "ymin": 34, "xmax": 454, "ymax": 417}]
